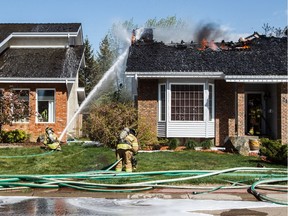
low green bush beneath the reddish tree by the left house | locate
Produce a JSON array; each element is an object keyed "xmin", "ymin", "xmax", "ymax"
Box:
[{"xmin": 1, "ymin": 129, "xmax": 29, "ymax": 143}]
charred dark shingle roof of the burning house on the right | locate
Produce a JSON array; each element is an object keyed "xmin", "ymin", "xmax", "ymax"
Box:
[{"xmin": 126, "ymin": 37, "xmax": 287, "ymax": 76}]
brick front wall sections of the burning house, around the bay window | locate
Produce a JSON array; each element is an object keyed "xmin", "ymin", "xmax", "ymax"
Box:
[{"xmin": 138, "ymin": 79, "xmax": 288, "ymax": 146}]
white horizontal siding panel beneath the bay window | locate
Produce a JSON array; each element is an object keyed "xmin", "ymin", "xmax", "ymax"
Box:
[{"xmin": 168, "ymin": 122, "xmax": 215, "ymax": 138}]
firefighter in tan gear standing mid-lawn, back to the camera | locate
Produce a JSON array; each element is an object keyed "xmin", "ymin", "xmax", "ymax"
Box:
[{"xmin": 116, "ymin": 128, "xmax": 138, "ymax": 172}]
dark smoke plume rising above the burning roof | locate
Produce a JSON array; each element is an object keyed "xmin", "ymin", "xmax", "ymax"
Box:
[{"xmin": 194, "ymin": 23, "xmax": 225, "ymax": 42}]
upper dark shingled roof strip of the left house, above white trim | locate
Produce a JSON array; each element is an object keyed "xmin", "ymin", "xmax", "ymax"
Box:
[{"xmin": 0, "ymin": 23, "xmax": 81, "ymax": 43}]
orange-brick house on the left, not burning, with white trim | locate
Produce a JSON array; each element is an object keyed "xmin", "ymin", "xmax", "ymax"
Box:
[{"xmin": 0, "ymin": 23, "xmax": 85, "ymax": 141}]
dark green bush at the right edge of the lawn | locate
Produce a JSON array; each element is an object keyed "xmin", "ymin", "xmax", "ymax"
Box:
[{"xmin": 259, "ymin": 138, "xmax": 287, "ymax": 165}]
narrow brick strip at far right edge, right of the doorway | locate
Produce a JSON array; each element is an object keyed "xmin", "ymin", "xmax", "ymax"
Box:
[{"xmin": 278, "ymin": 83, "xmax": 288, "ymax": 144}]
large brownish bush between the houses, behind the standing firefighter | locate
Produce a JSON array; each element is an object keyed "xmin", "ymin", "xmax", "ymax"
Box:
[{"xmin": 83, "ymin": 101, "xmax": 137, "ymax": 148}]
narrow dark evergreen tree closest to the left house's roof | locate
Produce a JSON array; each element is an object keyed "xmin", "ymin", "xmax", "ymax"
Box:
[{"xmin": 79, "ymin": 38, "xmax": 96, "ymax": 94}]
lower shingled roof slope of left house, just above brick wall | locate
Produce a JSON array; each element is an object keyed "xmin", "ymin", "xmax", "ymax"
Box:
[{"xmin": 0, "ymin": 46, "xmax": 84, "ymax": 79}]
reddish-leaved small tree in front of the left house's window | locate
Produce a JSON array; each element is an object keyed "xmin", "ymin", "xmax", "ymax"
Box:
[{"xmin": 0, "ymin": 89, "xmax": 31, "ymax": 132}]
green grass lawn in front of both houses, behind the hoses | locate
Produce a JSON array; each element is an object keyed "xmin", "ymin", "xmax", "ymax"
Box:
[{"xmin": 0, "ymin": 144, "xmax": 287, "ymax": 184}]
